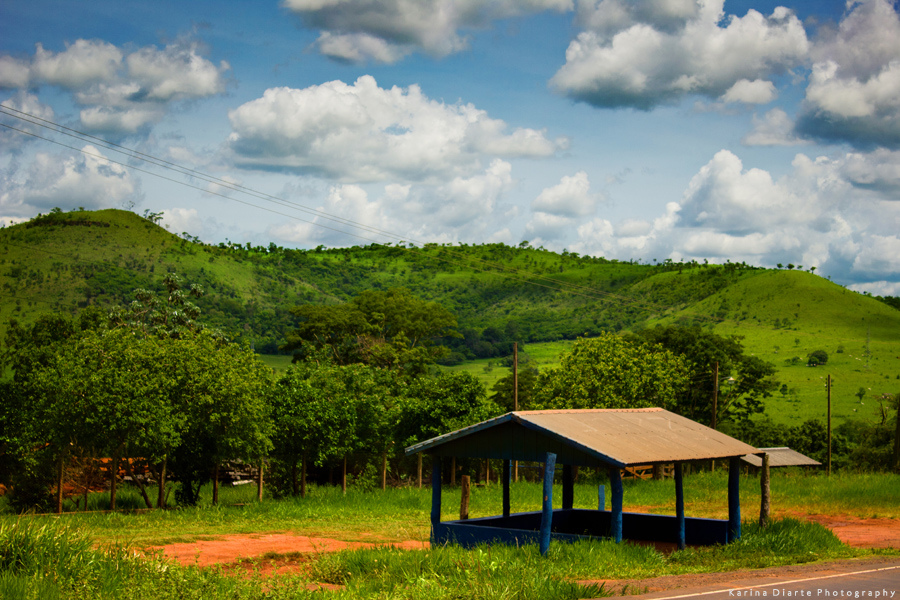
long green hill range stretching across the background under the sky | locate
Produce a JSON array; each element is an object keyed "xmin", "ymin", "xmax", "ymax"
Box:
[{"xmin": 0, "ymin": 210, "xmax": 900, "ymax": 422}]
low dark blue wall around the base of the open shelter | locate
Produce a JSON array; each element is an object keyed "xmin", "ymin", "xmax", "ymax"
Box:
[{"xmin": 431, "ymin": 508, "xmax": 728, "ymax": 547}]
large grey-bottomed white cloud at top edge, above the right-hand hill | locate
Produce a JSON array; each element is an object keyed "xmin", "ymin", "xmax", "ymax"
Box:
[{"xmin": 551, "ymin": 0, "xmax": 809, "ymax": 110}]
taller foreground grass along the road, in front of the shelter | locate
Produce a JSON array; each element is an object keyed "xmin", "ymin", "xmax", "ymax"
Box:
[{"xmin": 0, "ymin": 519, "xmax": 860, "ymax": 600}]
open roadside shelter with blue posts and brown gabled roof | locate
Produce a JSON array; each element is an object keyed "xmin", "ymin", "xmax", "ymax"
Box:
[{"xmin": 406, "ymin": 408, "xmax": 760, "ymax": 553}]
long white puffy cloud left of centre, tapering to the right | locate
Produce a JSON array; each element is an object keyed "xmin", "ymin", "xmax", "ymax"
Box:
[{"xmin": 228, "ymin": 75, "xmax": 565, "ymax": 182}]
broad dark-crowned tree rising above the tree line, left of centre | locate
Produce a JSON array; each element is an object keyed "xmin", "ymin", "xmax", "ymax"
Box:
[{"xmin": 281, "ymin": 288, "xmax": 458, "ymax": 375}]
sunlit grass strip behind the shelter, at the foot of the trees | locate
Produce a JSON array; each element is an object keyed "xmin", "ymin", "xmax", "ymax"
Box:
[{"xmin": 0, "ymin": 470, "xmax": 900, "ymax": 546}]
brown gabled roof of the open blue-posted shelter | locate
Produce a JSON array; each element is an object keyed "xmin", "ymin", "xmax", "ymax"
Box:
[{"xmin": 406, "ymin": 408, "xmax": 759, "ymax": 468}]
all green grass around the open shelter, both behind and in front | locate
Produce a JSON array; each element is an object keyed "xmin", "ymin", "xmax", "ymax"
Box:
[{"xmin": 0, "ymin": 471, "xmax": 900, "ymax": 599}]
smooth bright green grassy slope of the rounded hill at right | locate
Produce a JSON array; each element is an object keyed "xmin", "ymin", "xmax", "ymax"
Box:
[{"xmin": 663, "ymin": 271, "xmax": 900, "ymax": 423}]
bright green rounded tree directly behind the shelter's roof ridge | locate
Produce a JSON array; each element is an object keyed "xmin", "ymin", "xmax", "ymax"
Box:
[{"xmin": 535, "ymin": 333, "xmax": 689, "ymax": 409}]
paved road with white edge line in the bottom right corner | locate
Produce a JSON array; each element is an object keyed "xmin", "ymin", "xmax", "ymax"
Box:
[{"xmin": 604, "ymin": 557, "xmax": 900, "ymax": 600}]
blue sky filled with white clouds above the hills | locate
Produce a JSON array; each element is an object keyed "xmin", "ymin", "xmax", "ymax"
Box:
[{"xmin": 0, "ymin": 0, "xmax": 900, "ymax": 295}]
